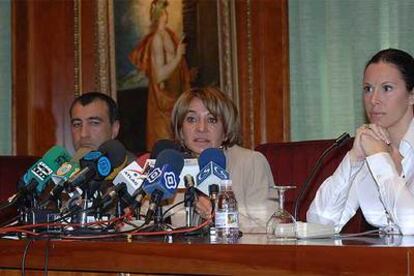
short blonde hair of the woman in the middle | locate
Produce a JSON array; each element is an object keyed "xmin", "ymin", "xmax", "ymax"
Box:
[{"xmin": 171, "ymin": 87, "xmax": 241, "ymax": 147}]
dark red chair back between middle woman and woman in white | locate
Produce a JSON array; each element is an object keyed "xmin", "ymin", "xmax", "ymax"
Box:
[{"xmin": 256, "ymin": 140, "xmax": 367, "ymax": 233}]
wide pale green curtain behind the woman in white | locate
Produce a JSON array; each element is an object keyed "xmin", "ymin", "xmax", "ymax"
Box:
[{"xmin": 288, "ymin": 0, "xmax": 414, "ymax": 141}]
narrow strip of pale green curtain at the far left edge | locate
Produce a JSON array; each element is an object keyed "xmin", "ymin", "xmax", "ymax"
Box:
[{"xmin": 0, "ymin": 0, "xmax": 12, "ymax": 155}]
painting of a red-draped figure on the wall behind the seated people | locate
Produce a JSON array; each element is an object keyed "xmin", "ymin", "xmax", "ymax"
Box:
[{"xmin": 113, "ymin": 0, "xmax": 223, "ymax": 153}]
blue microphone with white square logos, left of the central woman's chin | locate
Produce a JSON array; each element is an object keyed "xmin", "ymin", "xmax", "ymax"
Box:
[{"xmin": 142, "ymin": 149, "xmax": 184, "ymax": 224}]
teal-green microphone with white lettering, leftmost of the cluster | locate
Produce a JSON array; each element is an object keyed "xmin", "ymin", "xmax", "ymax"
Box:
[{"xmin": 8, "ymin": 146, "xmax": 71, "ymax": 204}]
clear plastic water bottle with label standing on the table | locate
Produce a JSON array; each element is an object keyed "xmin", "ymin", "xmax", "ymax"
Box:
[{"xmin": 215, "ymin": 180, "xmax": 239, "ymax": 243}]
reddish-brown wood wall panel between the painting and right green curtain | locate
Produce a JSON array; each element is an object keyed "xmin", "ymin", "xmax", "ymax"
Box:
[{"xmin": 236, "ymin": 0, "xmax": 290, "ymax": 146}]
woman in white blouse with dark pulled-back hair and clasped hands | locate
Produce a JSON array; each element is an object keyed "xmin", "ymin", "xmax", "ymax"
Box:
[{"xmin": 307, "ymin": 49, "xmax": 414, "ymax": 234}]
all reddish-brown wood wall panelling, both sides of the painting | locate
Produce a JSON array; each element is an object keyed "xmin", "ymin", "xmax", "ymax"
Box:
[{"xmin": 12, "ymin": 0, "xmax": 289, "ymax": 156}]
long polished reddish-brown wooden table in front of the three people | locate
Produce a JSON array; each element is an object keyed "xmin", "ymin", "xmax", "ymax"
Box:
[{"xmin": 0, "ymin": 234, "xmax": 414, "ymax": 275}]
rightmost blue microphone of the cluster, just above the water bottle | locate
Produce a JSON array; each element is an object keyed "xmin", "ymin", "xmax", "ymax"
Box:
[{"xmin": 196, "ymin": 148, "xmax": 230, "ymax": 196}]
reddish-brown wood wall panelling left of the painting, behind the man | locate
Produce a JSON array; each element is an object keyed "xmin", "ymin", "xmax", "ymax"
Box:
[{"xmin": 12, "ymin": 0, "xmax": 95, "ymax": 156}]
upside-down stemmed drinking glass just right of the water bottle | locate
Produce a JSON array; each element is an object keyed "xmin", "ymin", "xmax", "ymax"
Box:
[{"xmin": 266, "ymin": 186, "xmax": 296, "ymax": 241}]
